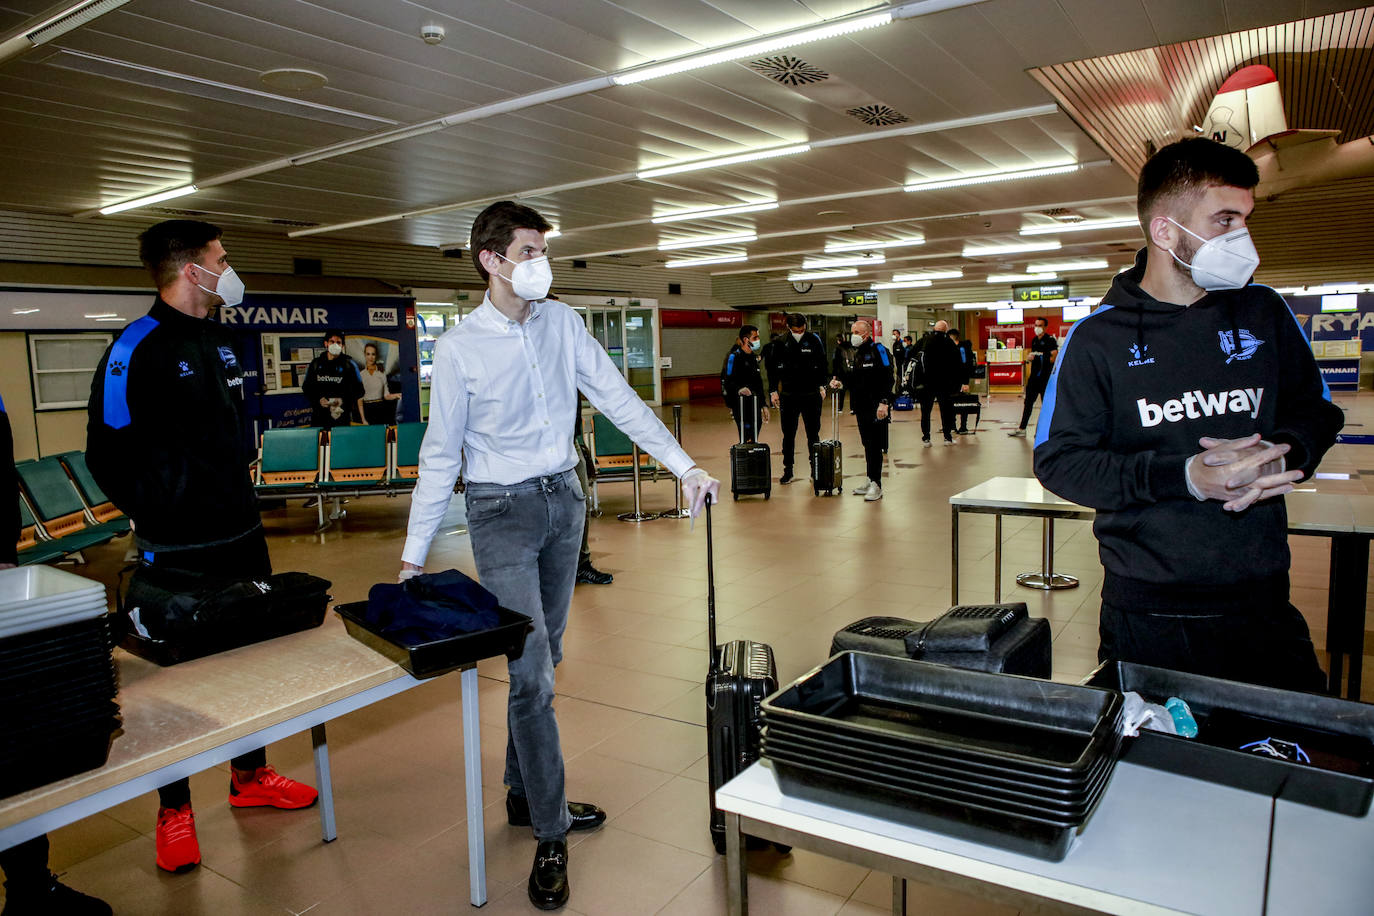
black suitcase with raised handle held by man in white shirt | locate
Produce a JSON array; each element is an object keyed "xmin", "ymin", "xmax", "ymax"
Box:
[{"xmin": 706, "ymin": 496, "xmax": 790, "ymax": 853}]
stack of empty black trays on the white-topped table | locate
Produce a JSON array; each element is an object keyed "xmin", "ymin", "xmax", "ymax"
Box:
[{"xmin": 763, "ymin": 652, "xmax": 1121, "ymax": 861}]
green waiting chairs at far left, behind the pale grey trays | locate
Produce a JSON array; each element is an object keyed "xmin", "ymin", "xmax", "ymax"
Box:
[{"xmin": 14, "ymin": 452, "xmax": 129, "ymax": 566}]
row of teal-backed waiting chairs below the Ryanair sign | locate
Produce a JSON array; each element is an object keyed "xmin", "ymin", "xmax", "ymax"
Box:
[{"xmin": 253, "ymin": 423, "xmax": 427, "ymax": 530}]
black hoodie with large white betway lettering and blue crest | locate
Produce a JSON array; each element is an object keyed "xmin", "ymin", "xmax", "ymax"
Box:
[{"xmin": 1035, "ymin": 250, "xmax": 1344, "ymax": 610}]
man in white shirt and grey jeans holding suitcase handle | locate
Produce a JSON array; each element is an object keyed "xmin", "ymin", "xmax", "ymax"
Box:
[{"xmin": 401, "ymin": 201, "xmax": 720, "ymax": 909}]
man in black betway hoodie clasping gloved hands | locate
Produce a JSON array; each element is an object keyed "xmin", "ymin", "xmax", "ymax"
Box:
[{"xmin": 1035, "ymin": 137, "xmax": 1344, "ymax": 691}]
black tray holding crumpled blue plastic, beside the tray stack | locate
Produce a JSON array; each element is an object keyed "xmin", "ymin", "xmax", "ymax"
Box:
[{"xmin": 1088, "ymin": 662, "xmax": 1374, "ymax": 817}]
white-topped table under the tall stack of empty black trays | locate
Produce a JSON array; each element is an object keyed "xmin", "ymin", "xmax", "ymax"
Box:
[{"xmin": 716, "ymin": 762, "xmax": 1297, "ymax": 916}]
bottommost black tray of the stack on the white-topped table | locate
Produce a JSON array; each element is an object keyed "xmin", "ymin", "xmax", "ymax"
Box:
[{"xmin": 768, "ymin": 761, "xmax": 1083, "ymax": 862}]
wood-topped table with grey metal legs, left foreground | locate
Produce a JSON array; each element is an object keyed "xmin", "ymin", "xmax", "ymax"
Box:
[{"xmin": 0, "ymin": 614, "xmax": 486, "ymax": 906}]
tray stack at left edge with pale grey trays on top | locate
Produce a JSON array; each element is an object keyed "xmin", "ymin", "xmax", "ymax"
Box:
[{"xmin": 0, "ymin": 567, "xmax": 120, "ymax": 797}]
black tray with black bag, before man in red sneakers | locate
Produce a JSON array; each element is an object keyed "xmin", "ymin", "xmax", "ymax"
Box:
[{"xmin": 118, "ymin": 564, "xmax": 331, "ymax": 665}]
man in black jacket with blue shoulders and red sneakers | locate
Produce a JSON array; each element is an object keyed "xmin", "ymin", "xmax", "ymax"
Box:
[{"xmin": 87, "ymin": 220, "xmax": 316, "ymax": 872}]
